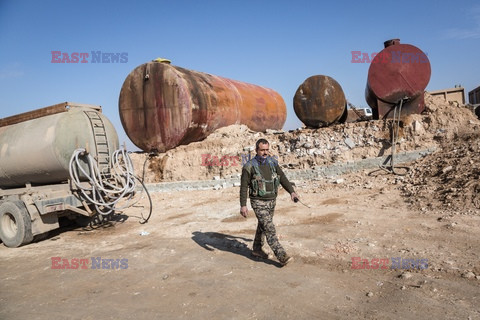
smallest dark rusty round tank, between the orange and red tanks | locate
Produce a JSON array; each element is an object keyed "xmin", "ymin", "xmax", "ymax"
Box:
[{"xmin": 293, "ymin": 75, "xmax": 346, "ymax": 128}]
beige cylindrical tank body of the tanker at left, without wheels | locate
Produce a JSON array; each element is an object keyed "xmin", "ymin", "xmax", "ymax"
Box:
[{"xmin": 0, "ymin": 102, "xmax": 119, "ymax": 189}]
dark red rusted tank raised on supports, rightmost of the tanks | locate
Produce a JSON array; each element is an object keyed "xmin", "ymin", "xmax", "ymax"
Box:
[{"xmin": 365, "ymin": 39, "xmax": 431, "ymax": 119}]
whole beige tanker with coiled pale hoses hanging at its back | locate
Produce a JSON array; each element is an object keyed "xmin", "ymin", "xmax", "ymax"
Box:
[{"xmin": 0, "ymin": 102, "xmax": 135, "ymax": 247}]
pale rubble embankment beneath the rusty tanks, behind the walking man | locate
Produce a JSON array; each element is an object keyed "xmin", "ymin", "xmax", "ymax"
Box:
[{"xmin": 132, "ymin": 93, "xmax": 480, "ymax": 183}]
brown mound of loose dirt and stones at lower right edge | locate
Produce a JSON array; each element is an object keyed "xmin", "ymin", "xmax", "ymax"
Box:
[{"xmin": 402, "ymin": 133, "xmax": 480, "ymax": 215}]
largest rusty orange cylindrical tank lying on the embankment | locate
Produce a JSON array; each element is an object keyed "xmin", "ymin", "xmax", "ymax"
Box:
[{"xmin": 119, "ymin": 61, "xmax": 286, "ymax": 152}]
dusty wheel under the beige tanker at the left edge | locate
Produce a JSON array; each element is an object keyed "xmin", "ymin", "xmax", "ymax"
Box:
[{"xmin": 0, "ymin": 201, "xmax": 33, "ymax": 248}]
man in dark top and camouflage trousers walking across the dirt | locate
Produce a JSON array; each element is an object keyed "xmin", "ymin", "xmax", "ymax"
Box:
[{"xmin": 240, "ymin": 139, "xmax": 299, "ymax": 265}]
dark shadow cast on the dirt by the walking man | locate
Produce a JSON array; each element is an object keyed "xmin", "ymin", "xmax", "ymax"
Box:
[{"xmin": 192, "ymin": 231, "xmax": 282, "ymax": 268}]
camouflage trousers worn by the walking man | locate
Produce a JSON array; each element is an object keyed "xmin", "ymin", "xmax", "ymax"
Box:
[{"xmin": 250, "ymin": 199, "xmax": 287, "ymax": 260}]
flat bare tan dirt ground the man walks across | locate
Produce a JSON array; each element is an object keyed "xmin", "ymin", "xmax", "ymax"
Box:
[{"xmin": 0, "ymin": 162, "xmax": 480, "ymax": 320}]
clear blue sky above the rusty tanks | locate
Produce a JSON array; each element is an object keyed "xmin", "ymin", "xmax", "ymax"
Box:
[{"xmin": 0, "ymin": 0, "xmax": 480, "ymax": 148}]
